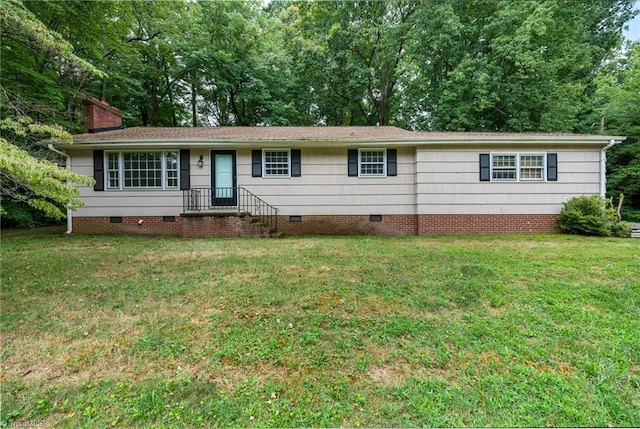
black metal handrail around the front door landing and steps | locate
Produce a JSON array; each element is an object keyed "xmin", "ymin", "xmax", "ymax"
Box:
[{"xmin": 182, "ymin": 187, "xmax": 279, "ymax": 233}]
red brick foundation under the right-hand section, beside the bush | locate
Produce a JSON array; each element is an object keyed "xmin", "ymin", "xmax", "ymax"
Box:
[{"xmin": 418, "ymin": 215, "xmax": 560, "ymax": 235}]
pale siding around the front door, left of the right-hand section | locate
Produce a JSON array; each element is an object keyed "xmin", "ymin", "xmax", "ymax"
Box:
[{"xmin": 70, "ymin": 144, "xmax": 416, "ymax": 216}]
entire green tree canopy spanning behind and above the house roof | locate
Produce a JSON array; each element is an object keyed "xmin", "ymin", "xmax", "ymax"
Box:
[{"xmin": 0, "ymin": 0, "xmax": 639, "ymax": 221}]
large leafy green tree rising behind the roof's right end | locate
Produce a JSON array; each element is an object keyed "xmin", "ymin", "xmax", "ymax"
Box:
[{"xmin": 404, "ymin": 0, "xmax": 633, "ymax": 132}]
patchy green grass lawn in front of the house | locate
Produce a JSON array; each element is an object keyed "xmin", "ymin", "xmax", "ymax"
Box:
[{"xmin": 0, "ymin": 229, "xmax": 640, "ymax": 428}]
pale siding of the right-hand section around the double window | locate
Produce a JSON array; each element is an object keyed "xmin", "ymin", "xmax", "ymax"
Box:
[{"xmin": 416, "ymin": 147, "xmax": 600, "ymax": 214}]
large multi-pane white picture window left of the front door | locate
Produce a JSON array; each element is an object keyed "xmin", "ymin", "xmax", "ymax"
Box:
[{"xmin": 105, "ymin": 151, "xmax": 180, "ymax": 189}]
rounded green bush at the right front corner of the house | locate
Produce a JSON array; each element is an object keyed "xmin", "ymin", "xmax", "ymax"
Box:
[{"xmin": 558, "ymin": 195, "xmax": 629, "ymax": 236}]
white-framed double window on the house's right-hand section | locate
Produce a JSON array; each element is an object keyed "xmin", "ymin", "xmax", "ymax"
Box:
[{"xmin": 491, "ymin": 153, "xmax": 546, "ymax": 182}]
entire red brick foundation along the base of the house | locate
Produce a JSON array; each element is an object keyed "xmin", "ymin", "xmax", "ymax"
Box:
[{"xmin": 73, "ymin": 215, "xmax": 560, "ymax": 238}]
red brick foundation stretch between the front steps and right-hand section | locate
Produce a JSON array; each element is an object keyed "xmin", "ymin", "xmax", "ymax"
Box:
[{"xmin": 278, "ymin": 215, "xmax": 418, "ymax": 235}]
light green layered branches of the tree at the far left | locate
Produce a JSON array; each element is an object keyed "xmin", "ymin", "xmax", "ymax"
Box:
[{"xmin": 0, "ymin": 0, "xmax": 98, "ymax": 219}]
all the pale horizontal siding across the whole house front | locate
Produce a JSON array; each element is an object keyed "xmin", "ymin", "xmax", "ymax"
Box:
[{"xmin": 69, "ymin": 142, "xmax": 600, "ymax": 216}]
